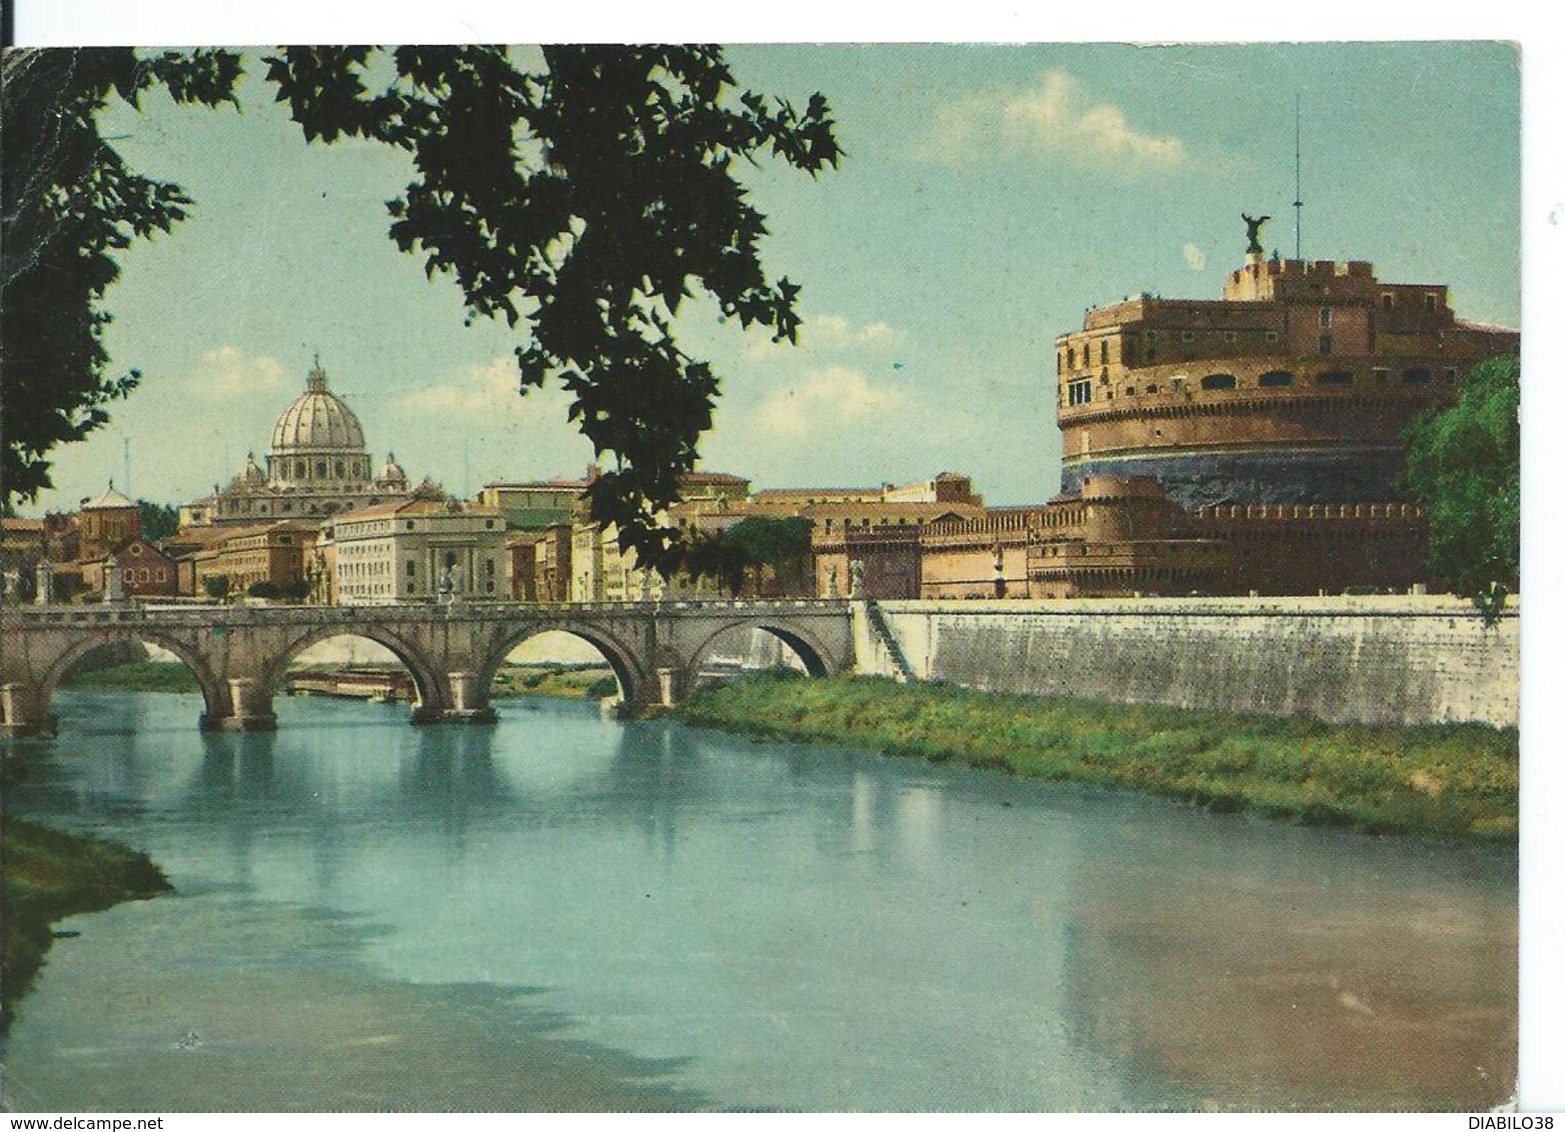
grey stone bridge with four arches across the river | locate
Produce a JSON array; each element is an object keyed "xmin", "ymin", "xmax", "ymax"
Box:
[{"xmin": 0, "ymin": 600, "xmax": 859, "ymax": 736}]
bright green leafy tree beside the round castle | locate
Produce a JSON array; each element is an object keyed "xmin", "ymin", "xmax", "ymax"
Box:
[{"xmin": 1405, "ymin": 355, "xmax": 1521, "ymax": 620}]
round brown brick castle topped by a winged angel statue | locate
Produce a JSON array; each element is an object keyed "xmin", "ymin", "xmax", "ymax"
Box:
[{"xmin": 907, "ymin": 216, "xmax": 1520, "ymax": 598}]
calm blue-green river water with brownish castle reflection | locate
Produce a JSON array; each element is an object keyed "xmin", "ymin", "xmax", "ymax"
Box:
[{"xmin": 3, "ymin": 690, "xmax": 1516, "ymax": 1112}]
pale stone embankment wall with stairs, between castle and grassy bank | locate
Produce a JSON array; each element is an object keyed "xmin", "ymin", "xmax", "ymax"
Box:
[{"xmin": 854, "ymin": 597, "xmax": 1521, "ymax": 726}]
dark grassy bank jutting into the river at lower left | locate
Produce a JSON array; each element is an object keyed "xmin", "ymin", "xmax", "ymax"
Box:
[{"xmin": 0, "ymin": 819, "xmax": 169, "ymax": 1032}]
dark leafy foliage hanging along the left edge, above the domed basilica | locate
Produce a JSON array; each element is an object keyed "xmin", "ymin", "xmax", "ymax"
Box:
[{"xmin": 0, "ymin": 49, "xmax": 239, "ymax": 512}]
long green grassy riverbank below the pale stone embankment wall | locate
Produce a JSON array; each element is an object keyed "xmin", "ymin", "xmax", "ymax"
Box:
[{"xmin": 676, "ymin": 673, "xmax": 1518, "ymax": 841}]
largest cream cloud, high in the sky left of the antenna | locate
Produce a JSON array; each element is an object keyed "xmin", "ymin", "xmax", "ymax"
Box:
[{"xmin": 919, "ymin": 70, "xmax": 1185, "ymax": 169}]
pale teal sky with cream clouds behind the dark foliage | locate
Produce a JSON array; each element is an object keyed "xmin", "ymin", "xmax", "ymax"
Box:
[{"xmin": 12, "ymin": 42, "xmax": 1521, "ymax": 512}]
